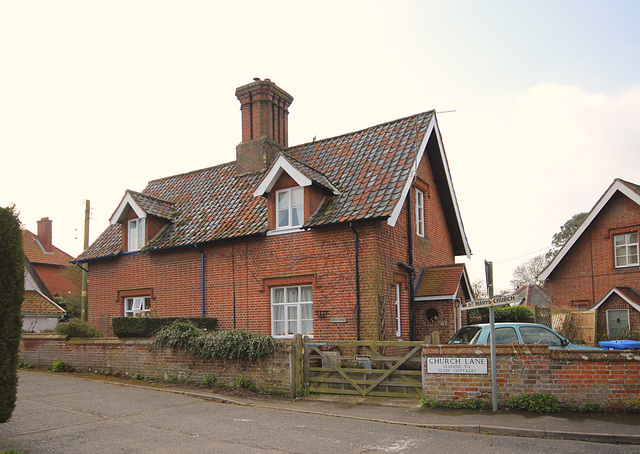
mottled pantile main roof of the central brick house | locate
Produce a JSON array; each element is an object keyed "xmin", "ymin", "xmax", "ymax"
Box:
[{"xmin": 78, "ymin": 111, "xmax": 464, "ymax": 261}]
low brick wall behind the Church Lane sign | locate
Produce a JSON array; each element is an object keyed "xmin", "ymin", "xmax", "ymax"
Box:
[{"xmin": 422, "ymin": 345, "xmax": 640, "ymax": 409}]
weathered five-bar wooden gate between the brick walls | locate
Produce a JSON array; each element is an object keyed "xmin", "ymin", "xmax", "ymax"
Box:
[{"xmin": 303, "ymin": 337, "xmax": 423, "ymax": 397}]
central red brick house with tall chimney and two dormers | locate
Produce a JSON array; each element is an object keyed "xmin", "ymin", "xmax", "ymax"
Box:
[{"xmin": 77, "ymin": 79, "xmax": 472, "ymax": 340}]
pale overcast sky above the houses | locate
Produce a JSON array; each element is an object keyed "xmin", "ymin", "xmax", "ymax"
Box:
[{"xmin": 0, "ymin": 0, "xmax": 640, "ymax": 290}]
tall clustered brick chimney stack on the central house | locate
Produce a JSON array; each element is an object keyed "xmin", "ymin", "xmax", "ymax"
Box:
[{"xmin": 236, "ymin": 78, "xmax": 293, "ymax": 175}]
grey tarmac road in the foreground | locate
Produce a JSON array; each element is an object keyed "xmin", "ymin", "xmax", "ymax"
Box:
[{"xmin": 0, "ymin": 371, "xmax": 640, "ymax": 454}]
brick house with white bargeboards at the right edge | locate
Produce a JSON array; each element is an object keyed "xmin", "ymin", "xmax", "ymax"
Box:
[{"xmin": 539, "ymin": 179, "xmax": 640, "ymax": 337}]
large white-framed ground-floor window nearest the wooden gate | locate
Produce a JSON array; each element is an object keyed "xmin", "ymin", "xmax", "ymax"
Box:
[{"xmin": 271, "ymin": 285, "xmax": 313, "ymax": 337}]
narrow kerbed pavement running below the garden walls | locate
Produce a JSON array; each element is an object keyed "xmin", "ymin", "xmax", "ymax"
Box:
[{"xmin": 7, "ymin": 370, "xmax": 640, "ymax": 445}]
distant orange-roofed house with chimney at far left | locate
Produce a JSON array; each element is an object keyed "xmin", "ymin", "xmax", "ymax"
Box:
[{"xmin": 22, "ymin": 218, "xmax": 80, "ymax": 332}]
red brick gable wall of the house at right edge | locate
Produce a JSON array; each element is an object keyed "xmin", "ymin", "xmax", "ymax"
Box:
[{"xmin": 548, "ymin": 193, "xmax": 640, "ymax": 308}]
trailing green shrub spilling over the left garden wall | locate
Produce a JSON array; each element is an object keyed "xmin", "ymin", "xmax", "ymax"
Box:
[{"xmin": 152, "ymin": 320, "xmax": 283, "ymax": 361}]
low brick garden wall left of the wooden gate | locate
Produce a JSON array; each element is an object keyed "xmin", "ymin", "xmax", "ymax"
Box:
[{"xmin": 20, "ymin": 334, "xmax": 294, "ymax": 395}]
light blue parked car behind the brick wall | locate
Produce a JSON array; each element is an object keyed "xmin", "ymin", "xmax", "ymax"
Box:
[{"xmin": 449, "ymin": 323, "xmax": 600, "ymax": 350}]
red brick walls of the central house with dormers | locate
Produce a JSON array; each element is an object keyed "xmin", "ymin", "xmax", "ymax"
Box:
[{"xmin": 88, "ymin": 153, "xmax": 454, "ymax": 340}]
